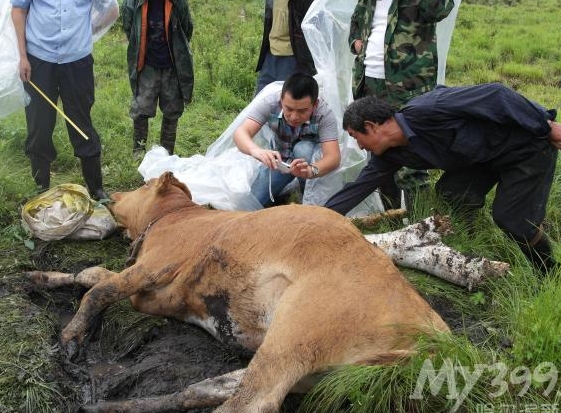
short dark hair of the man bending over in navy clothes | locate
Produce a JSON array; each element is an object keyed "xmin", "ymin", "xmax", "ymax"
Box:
[{"xmin": 343, "ymin": 96, "xmax": 396, "ymax": 133}]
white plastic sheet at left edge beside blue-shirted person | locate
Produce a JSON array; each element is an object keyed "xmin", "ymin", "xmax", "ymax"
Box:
[{"xmin": 0, "ymin": 0, "xmax": 29, "ymax": 119}]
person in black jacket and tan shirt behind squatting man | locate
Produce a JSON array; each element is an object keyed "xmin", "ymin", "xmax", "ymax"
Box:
[{"xmin": 255, "ymin": 0, "xmax": 316, "ymax": 94}]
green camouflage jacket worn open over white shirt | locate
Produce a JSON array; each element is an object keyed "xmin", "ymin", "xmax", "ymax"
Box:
[{"xmin": 349, "ymin": 0, "xmax": 454, "ymax": 103}]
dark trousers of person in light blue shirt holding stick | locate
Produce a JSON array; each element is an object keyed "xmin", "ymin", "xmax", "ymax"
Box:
[{"xmin": 24, "ymin": 55, "xmax": 101, "ymax": 162}]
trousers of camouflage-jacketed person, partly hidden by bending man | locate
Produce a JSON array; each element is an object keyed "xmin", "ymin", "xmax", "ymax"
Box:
[{"xmin": 364, "ymin": 77, "xmax": 429, "ymax": 195}]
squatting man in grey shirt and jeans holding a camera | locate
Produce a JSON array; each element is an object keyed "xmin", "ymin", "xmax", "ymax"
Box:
[{"xmin": 234, "ymin": 73, "xmax": 341, "ymax": 207}]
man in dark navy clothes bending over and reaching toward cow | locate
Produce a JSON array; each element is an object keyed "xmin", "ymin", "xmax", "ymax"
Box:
[{"xmin": 325, "ymin": 83, "xmax": 561, "ymax": 270}]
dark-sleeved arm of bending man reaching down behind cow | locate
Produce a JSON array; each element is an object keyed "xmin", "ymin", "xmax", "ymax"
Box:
[{"xmin": 324, "ymin": 156, "xmax": 398, "ymax": 215}]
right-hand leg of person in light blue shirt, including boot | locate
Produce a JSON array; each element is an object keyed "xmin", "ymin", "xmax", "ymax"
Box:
[{"xmin": 58, "ymin": 55, "xmax": 109, "ymax": 199}]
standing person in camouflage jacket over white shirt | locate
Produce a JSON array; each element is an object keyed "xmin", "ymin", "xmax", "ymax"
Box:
[{"xmin": 349, "ymin": 0, "xmax": 454, "ymax": 209}]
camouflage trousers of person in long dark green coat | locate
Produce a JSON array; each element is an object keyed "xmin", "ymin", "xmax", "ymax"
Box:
[{"xmin": 130, "ymin": 65, "xmax": 185, "ymax": 120}]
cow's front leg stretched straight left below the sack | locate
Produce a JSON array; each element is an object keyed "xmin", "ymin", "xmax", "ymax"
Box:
[{"xmin": 26, "ymin": 267, "xmax": 116, "ymax": 289}]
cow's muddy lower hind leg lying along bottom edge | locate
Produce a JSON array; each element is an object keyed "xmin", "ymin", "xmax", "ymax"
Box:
[{"xmin": 81, "ymin": 369, "xmax": 246, "ymax": 413}]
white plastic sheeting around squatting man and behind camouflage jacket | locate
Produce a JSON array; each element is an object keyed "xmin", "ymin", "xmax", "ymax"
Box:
[{"xmin": 139, "ymin": 0, "xmax": 459, "ymax": 216}]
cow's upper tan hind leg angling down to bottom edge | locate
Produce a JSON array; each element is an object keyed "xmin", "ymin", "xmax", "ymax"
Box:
[{"xmin": 215, "ymin": 288, "xmax": 337, "ymax": 413}]
